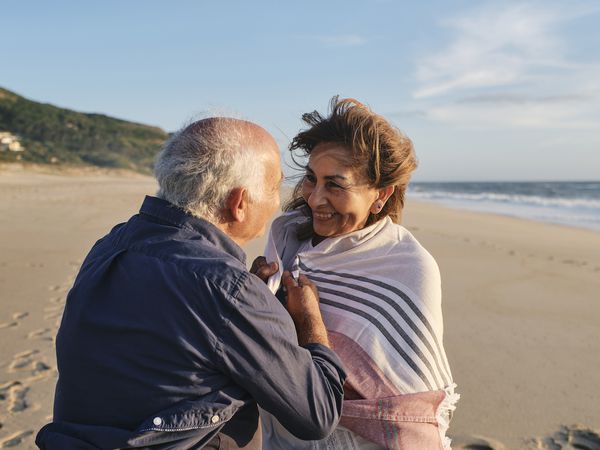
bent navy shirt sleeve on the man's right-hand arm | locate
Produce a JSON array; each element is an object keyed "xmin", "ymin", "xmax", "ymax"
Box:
[{"xmin": 212, "ymin": 273, "xmax": 346, "ymax": 440}]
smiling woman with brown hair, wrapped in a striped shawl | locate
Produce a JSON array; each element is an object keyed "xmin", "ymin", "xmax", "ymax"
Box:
[{"xmin": 262, "ymin": 97, "xmax": 458, "ymax": 450}]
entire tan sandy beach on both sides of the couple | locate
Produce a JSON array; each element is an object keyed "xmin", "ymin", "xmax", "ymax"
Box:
[{"xmin": 0, "ymin": 166, "xmax": 600, "ymax": 450}]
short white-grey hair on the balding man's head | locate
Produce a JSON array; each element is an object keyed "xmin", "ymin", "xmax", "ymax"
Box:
[{"xmin": 154, "ymin": 117, "xmax": 264, "ymax": 222}]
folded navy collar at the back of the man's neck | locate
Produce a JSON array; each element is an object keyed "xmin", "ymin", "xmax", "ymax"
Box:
[{"xmin": 140, "ymin": 195, "xmax": 246, "ymax": 265}]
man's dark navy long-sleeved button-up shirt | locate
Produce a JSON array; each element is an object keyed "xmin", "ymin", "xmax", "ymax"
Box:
[{"xmin": 37, "ymin": 197, "xmax": 345, "ymax": 449}]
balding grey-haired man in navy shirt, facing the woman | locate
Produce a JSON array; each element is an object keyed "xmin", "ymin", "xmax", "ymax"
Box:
[{"xmin": 36, "ymin": 118, "xmax": 345, "ymax": 450}]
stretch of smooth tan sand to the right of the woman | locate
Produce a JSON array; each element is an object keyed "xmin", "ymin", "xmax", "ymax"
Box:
[{"xmin": 404, "ymin": 202, "xmax": 600, "ymax": 450}]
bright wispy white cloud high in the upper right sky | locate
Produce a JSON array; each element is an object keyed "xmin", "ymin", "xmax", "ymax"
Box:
[{"xmin": 415, "ymin": 4, "xmax": 567, "ymax": 98}]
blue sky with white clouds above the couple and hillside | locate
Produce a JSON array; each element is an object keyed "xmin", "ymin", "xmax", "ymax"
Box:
[{"xmin": 0, "ymin": 0, "xmax": 600, "ymax": 181}]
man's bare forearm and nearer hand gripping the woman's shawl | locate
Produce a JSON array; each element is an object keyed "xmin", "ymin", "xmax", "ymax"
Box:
[{"xmin": 282, "ymin": 270, "xmax": 330, "ymax": 347}]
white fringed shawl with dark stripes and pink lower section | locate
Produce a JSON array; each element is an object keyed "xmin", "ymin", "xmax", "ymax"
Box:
[{"xmin": 262, "ymin": 211, "xmax": 458, "ymax": 450}]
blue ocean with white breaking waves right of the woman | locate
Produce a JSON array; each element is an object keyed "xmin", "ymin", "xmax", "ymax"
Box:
[{"xmin": 407, "ymin": 181, "xmax": 600, "ymax": 230}]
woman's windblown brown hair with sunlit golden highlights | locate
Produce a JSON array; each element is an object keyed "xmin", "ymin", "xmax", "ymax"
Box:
[{"xmin": 284, "ymin": 96, "xmax": 417, "ymax": 225}]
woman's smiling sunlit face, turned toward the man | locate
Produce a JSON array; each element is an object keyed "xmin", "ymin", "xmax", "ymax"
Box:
[{"xmin": 302, "ymin": 143, "xmax": 378, "ymax": 237}]
